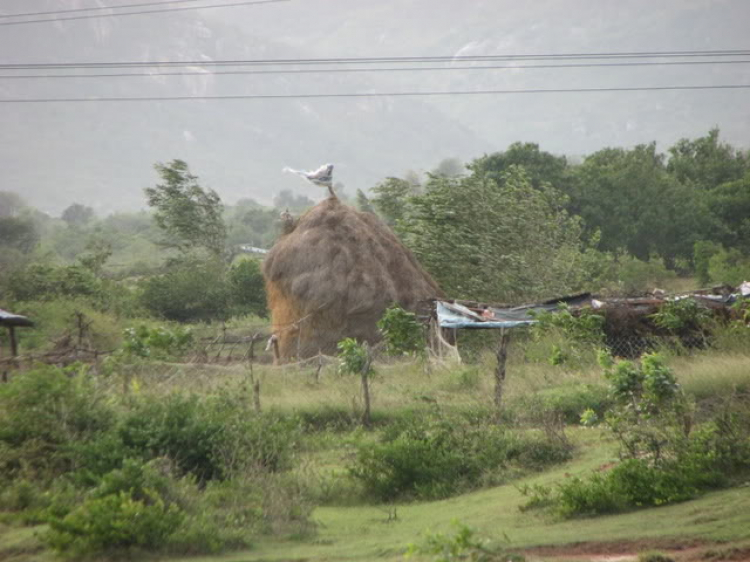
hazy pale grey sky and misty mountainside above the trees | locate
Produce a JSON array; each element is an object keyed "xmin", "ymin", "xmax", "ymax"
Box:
[{"xmin": 0, "ymin": 0, "xmax": 750, "ymax": 213}]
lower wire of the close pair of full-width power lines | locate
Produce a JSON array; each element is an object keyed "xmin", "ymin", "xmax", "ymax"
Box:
[{"xmin": 0, "ymin": 60, "xmax": 750, "ymax": 80}]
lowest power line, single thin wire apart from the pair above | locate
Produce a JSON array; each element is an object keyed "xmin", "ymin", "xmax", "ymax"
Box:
[{"xmin": 0, "ymin": 84, "xmax": 750, "ymax": 103}]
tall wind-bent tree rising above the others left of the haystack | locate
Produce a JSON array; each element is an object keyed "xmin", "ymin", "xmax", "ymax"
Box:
[{"xmin": 145, "ymin": 160, "xmax": 227, "ymax": 256}]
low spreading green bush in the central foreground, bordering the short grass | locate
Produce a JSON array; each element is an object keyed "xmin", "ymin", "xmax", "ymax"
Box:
[{"xmin": 349, "ymin": 416, "xmax": 570, "ymax": 501}]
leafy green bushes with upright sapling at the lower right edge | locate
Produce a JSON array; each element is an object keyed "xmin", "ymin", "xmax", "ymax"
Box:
[{"xmin": 526, "ymin": 355, "xmax": 750, "ymax": 517}]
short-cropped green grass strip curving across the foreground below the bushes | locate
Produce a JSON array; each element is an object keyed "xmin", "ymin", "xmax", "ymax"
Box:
[{"xmin": 5, "ymin": 429, "xmax": 750, "ymax": 562}]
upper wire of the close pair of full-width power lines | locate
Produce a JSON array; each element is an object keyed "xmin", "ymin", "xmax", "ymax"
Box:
[{"xmin": 0, "ymin": 49, "xmax": 750, "ymax": 70}]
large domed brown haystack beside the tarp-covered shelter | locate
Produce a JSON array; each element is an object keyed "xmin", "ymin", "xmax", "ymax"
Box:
[{"xmin": 263, "ymin": 197, "xmax": 442, "ymax": 360}]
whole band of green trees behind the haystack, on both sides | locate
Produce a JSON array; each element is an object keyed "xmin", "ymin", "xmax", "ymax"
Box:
[{"xmin": 0, "ymin": 129, "xmax": 750, "ymax": 321}]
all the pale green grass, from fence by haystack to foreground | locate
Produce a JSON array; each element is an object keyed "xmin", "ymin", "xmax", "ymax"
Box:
[{"xmin": 0, "ymin": 344, "xmax": 750, "ymax": 562}]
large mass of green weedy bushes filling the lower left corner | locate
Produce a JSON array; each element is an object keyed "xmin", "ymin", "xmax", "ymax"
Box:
[{"xmin": 0, "ymin": 367, "xmax": 310, "ymax": 559}]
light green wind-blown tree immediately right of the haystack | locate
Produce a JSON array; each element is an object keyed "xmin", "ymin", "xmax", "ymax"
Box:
[{"xmin": 397, "ymin": 166, "xmax": 582, "ymax": 302}]
